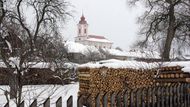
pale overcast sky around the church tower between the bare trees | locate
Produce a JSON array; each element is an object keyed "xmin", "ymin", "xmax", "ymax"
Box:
[{"xmin": 63, "ymin": 0, "xmax": 143, "ymax": 50}]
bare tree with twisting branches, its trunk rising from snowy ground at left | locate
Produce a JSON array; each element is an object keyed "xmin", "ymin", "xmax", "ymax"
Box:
[{"xmin": 0, "ymin": 0, "xmax": 70, "ymax": 107}]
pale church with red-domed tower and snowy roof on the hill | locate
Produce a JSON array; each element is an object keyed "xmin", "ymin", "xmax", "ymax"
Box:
[{"xmin": 75, "ymin": 15, "xmax": 113, "ymax": 49}]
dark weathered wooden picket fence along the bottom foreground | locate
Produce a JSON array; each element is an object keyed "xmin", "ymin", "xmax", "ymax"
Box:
[{"xmin": 4, "ymin": 83, "xmax": 190, "ymax": 107}]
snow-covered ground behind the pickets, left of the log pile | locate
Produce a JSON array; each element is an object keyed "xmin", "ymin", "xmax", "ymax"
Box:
[{"xmin": 0, "ymin": 83, "xmax": 79, "ymax": 107}]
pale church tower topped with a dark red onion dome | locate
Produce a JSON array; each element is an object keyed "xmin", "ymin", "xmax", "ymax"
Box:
[{"xmin": 75, "ymin": 15, "xmax": 88, "ymax": 42}]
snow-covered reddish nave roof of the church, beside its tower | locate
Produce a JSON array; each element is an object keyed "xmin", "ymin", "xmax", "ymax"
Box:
[{"xmin": 87, "ymin": 35, "xmax": 112, "ymax": 43}]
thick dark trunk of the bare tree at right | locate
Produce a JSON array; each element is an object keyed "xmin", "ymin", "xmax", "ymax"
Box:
[{"xmin": 162, "ymin": 4, "xmax": 175, "ymax": 61}]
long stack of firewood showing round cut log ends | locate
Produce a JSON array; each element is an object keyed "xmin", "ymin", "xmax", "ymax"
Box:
[{"xmin": 78, "ymin": 67, "xmax": 156, "ymax": 96}]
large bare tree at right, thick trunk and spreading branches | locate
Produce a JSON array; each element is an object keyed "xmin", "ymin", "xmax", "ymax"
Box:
[{"xmin": 129, "ymin": 0, "xmax": 190, "ymax": 60}]
